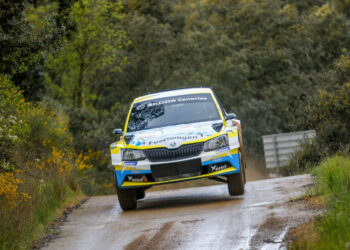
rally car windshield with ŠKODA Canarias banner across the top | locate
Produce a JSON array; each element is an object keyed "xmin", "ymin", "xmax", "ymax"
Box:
[{"xmin": 127, "ymin": 94, "xmax": 220, "ymax": 132}]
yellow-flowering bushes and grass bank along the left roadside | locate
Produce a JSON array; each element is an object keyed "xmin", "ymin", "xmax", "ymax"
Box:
[{"xmin": 0, "ymin": 76, "xmax": 93, "ymax": 249}]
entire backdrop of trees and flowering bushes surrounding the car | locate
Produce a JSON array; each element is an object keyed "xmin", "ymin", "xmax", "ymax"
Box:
[{"xmin": 0, "ymin": 0, "xmax": 350, "ymax": 248}]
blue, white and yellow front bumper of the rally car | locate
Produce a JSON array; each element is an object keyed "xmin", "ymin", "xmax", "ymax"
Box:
[{"xmin": 114, "ymin": 147, "xmax": 240, "ymax": 189}]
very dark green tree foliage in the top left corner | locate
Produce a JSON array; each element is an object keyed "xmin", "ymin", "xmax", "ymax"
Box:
[{"xmin": 0, "ymin": 0, "xmax": 74, "ymax": 100}]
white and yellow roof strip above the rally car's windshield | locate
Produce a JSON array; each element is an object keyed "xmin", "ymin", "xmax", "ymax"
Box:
[{"xmin": 134, "ymin": 88, "xmax": 213, "ymax": 103}]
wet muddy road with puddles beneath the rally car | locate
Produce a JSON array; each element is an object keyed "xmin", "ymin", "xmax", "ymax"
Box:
[{"xmin": 46, "ymin": 175, "xmax": 314, "ymax": 250}]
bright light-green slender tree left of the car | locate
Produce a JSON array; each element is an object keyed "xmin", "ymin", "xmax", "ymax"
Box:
[{"xmin": 46, "ymin": 0, "xmax": 129, "ymax": 189}]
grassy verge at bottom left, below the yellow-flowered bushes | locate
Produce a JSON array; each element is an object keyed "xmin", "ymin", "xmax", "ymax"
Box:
[{"xmin": 0, "ymin": 176, "xmax": 83, "ymax": 249}]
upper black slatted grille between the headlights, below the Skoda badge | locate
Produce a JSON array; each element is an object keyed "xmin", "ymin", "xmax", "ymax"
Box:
[{"xmin": 144, "ymin": 143, "xmax": 203, "ymax": 162}]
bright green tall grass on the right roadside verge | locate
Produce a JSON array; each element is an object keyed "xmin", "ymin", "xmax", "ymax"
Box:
[{"xmin": 291, "ymin": 155, "xmax": 350, "ymax": 249}]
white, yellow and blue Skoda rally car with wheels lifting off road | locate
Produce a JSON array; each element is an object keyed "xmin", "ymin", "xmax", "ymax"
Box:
[{"xmin": 110, "ymin": 88, "xmax": 245, "ymax": 210}]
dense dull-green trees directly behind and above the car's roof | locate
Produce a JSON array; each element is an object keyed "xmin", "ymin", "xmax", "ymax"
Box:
[{"xmin": 96, "ymin": 0, "xmax": 350, "ymax": 152}]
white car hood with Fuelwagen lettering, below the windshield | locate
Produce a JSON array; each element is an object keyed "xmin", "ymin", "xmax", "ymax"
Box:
[{"xmin": 128, "ymin": 120, "xmax": 222, "ymax": 149}]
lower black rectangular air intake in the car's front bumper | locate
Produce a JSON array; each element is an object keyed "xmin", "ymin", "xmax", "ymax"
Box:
[{"xmin": 151, "ymin": 159, "xmax": 202, "ymax": 181}]
